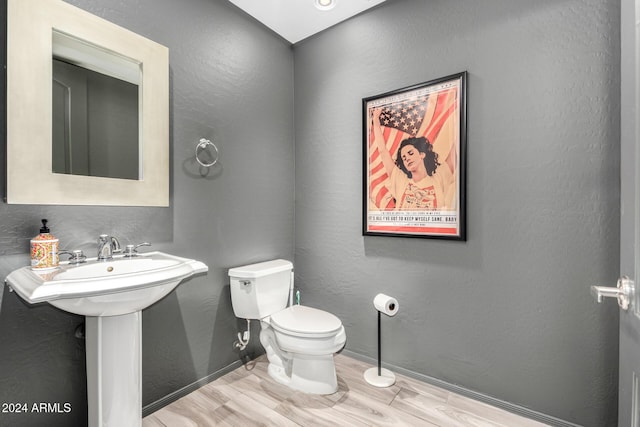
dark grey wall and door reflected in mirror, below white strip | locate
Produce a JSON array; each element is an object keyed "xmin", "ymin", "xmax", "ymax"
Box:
[{"xmin": 52, "ymin": 58, "xmax": 139, "ymax": 180}]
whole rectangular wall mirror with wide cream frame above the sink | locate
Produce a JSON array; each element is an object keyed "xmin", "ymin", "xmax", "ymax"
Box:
[{"xmin": 6, "ymin": 0, "xmax": 169, "ymax": 206}]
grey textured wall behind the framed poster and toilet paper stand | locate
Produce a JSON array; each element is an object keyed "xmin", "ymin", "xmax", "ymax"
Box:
[{"xmin": 294, "ymin": 0, "xmax": 620, "ymax": 427}]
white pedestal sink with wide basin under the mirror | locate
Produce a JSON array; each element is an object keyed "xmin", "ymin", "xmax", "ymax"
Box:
[{"xmin": 6, "ymin": 252, "xmax": 208, "ymax": 427}]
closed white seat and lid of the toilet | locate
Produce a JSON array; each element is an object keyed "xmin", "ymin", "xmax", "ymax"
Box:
[{"xmin": 270, "ymin": 305, "xmax": 342, "ymax": 338}]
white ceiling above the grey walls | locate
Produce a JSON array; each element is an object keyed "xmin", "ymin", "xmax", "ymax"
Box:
[{"xmin": 229, "ymin": 0, "xmax": 385, "ymax": 44}]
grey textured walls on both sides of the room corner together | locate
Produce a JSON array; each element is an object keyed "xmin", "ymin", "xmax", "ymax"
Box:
[{"xmin": 0, "ymin": 0, "xmax": 620, "ymax": 426}]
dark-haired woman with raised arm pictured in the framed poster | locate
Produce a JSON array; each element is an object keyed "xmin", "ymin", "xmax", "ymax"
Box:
[{"xmin": 372, "ymin": 108, "xmax": 455, "ymax": 210}]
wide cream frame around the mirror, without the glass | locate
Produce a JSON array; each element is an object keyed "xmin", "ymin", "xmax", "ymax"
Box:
[{"xmin": 6, "ymin": 0, "xmax": 169, "ymax": 206}]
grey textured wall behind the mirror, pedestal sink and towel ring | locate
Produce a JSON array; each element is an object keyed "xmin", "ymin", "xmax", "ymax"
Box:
[{"xmin": 0, "ymin": 0, "xmax": 294, "ymax": 427}]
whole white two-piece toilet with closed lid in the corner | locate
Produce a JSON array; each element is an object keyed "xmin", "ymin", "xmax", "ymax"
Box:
[{"xmin": 229, "ymin": 259, "xmax": 347, "ymax": 394}]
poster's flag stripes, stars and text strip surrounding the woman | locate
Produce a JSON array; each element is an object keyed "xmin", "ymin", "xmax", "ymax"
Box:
[{"xmin": 365, "ymin": 75, "xmax": 461, "ymax": 239}]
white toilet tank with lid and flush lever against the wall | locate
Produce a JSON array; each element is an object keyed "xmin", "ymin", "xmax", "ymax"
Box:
[{"xmin": 229, "ymin": 259, "xmax": 293, "ymax": 319}]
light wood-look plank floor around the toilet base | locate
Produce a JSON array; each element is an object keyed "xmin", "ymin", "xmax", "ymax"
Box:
[{"xmin": 142, "ymin": 354, "xmax": 545, "ymax": 427}]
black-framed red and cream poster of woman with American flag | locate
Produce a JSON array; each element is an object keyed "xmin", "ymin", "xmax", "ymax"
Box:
[{"xmin": 362, "ymin": 71, "xmax": 467, "ymax": 240}]
